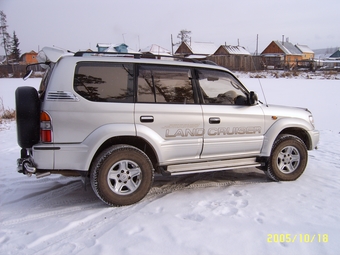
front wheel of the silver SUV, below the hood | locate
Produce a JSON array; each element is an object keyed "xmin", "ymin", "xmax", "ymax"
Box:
[{"xmin": 266, "ymin": 135, "xmax": 308, "ymax": 181}]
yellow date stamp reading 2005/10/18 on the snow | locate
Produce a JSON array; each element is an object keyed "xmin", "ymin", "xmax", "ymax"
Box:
[{"xmin": 267, "ymin": 234, "xmax": 328, "ymax": 243}]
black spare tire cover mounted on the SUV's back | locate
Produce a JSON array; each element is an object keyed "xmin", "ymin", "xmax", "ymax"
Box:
[{"xmin": 15, "ymin": 86, "xmax": 40, "ymax": 148}]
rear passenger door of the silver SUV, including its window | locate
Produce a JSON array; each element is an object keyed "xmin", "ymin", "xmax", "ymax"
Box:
[{"xmin": 135, "ymin": 64, "xmax": 204, "ymax": 164}]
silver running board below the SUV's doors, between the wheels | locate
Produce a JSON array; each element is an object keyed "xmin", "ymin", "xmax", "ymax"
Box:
[{"xmin": 167, "ymin": 158, "xmax": 262, "ymax": 175}]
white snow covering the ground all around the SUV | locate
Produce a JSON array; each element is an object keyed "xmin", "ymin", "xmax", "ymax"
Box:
[{"xmin": 0, "ymin": 74, "xmax": 340, "ymax": 255}]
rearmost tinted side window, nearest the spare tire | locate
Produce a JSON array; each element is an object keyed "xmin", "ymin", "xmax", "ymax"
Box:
[{"xmin": 73, "ymin": 62, "xmax": 133, "ymax": 103}]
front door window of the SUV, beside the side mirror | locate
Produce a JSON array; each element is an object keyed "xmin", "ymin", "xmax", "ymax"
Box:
[{"xmin": 198, "ymin": 69, "xmax": 247, "ymax": 105}]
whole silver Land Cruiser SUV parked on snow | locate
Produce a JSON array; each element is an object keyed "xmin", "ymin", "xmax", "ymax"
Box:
[{"xmin": 16, "ymin": 47, "xmax": 319, "ymax": 206}]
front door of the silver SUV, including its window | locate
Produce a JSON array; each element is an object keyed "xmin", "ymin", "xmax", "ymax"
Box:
[{"xmin": 197, "ymin": 69, "xmax": 264, "ymax": 159}]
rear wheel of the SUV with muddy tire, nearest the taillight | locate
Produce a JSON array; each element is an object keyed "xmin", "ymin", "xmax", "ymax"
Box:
[{"xmin": 90, "ymin": 145, "xmax": 154, "ymax": 206}]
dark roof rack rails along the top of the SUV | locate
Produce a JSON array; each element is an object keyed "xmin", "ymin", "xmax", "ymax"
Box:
[{"xmin": 74, "ymin": 51, "xmax": 217, "ymax": 65}]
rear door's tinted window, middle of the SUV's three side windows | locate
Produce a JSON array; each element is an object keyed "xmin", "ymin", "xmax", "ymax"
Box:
[{"xmin": 137, "ymin": 65, "xmax": 194, "ymax": 104}]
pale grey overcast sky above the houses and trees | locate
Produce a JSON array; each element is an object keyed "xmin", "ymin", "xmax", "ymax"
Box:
[{"xmin": 0, "ymin": 0, "xmax": 340, "ymax": 54}]
